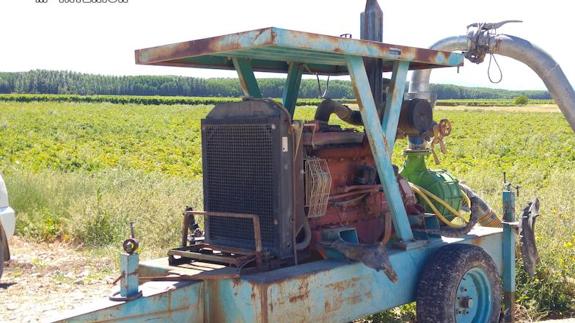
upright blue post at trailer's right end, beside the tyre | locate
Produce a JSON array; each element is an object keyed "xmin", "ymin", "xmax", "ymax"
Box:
[{"xmin": 503, "ymin": 183, "xmax": 516, "ymax": 322}]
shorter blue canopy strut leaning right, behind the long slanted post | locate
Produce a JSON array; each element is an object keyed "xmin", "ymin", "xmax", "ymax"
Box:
[{"xmin": 381, "ymin": 62, "xmax": 409, "ymax": 158}]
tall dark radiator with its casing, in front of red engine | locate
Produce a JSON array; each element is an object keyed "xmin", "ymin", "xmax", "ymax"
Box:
[{"xmin": 202, "ymin": 100, "xmax": 293, "ymax": 258}]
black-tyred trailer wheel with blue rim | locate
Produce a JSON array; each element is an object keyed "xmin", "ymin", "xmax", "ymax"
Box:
[{"xmin": 416, "ymin": 244, "xmax": 501, "ymax": 323}]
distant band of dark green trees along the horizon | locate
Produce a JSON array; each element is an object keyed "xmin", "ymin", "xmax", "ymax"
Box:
[{"xmin": 0, "ymin": 70, "xmax": 550, "ymax": 100}]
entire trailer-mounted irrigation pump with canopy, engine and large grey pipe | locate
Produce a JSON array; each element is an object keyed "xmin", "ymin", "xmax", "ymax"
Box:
[{"xmin": 57, "ymin": 0, "xmax": 575, "ymax": 322}]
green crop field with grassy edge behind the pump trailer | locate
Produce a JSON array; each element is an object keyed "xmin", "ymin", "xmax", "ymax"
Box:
[{"xmin": 0, "ymin": 100, "xmax": 575, "ymax": 319}]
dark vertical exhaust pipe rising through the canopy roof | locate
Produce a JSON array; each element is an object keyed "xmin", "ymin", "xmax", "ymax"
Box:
[{"xmin": 360, "ymin": 0, "xmax": 383, "ymax": 118}]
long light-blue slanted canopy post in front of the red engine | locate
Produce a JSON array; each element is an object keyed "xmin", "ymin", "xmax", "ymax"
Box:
[{"xmin": 346, "ymin": 56, "xmax": 413, "ymax": 243}]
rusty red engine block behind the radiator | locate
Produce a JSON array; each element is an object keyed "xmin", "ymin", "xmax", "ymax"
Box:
[{"xmin": 303, "ymin": 122, "xmax": 417, "ymax": 248}]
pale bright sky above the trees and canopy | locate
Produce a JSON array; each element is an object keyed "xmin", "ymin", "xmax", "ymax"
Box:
[{"xmin": 0, "ymin": 0, "xmax": 575, "ymax": 89}]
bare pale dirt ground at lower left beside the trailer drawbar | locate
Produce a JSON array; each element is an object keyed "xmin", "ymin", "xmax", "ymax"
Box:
[{"xmin": 0, "ymin": 237, "xmax": 117, "ymax": 322}]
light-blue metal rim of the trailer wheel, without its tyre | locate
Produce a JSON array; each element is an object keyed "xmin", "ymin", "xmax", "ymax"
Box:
[{"xmin": 455, "ymin": 268, "xmax": 493, "ymax": 323}]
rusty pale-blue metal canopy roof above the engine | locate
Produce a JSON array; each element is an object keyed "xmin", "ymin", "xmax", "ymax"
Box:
[{"xmin": 136, "ymin": 27, "xmax": 463, "ymax": 75}]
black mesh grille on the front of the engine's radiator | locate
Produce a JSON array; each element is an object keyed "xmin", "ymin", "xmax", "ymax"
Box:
[{"xmin": 203, "ymin": 124, "xmax": 277, "ymax": 248}]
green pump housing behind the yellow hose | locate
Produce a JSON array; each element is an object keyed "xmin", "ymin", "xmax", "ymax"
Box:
[{"xmin": 400, "ymin": 150, "xmax": 463, "ymax": 221}]
